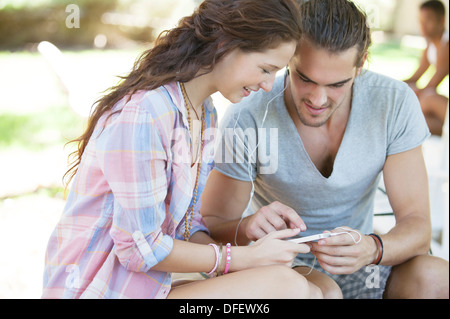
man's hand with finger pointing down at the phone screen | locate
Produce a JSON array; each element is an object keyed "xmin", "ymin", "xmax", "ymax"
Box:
[{"xmin": 245, "ymin": 202, "xmax": 306, "ymax": 241}]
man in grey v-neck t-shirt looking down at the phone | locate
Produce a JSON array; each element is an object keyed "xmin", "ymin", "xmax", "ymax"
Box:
[{"xmin": 201, "ymin": 0, "xmax": 449, "ymax": 298}]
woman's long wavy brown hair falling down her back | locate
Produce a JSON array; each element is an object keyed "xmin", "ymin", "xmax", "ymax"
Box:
[{"xmin": 63, "ymin": 0, "xmax": 301, "ymax": 185}]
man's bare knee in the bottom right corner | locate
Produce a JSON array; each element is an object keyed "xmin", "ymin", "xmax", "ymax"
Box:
[{"xmin": 384, "ymin": 255, "xmax": 449, "ymax": 299}]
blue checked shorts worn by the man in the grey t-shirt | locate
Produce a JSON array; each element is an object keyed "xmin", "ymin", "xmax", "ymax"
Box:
[{"xmin": 292, "ymin": 257, "xmax": 392, "ymax": 299}]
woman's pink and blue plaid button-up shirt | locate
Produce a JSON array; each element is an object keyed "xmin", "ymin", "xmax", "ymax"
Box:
[{"xmin": 42, "ymin": 83, "xmax": 217, "ymax": 298}]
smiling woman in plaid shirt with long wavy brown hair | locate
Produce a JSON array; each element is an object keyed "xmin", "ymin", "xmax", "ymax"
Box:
[{"xmin": 43, "ymin": 0, "xmax": 311, "ymax": 298}]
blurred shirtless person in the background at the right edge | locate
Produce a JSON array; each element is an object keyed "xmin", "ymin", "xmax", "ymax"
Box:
[{"xmin": 405, "ymin": 0, "xmax": 449, "ymax": 135}]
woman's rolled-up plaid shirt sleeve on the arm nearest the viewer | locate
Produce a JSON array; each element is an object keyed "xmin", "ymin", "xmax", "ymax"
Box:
[{"xmin": 96, "ymin": 105, "xmax": 173, "ymax": 272}]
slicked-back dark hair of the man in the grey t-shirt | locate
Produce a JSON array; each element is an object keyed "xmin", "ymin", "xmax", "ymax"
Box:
[{"xmin": 299, "ymin": 0, "xmax": 372, "ymax": 67}]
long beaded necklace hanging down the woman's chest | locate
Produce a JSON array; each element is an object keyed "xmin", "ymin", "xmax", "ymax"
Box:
[{"xmin": 180, "ymin": 83, "xmax": 206, "ymax": 241}]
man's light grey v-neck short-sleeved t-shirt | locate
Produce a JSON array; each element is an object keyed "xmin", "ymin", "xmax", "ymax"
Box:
[{"xmin": 215, "ymin": 70, "xmax": 430, "ymax": 250}]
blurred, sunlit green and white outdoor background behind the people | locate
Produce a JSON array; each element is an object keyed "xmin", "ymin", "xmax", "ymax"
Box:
[{"xmin": 0, "ymin": 0, "xmax": 449, "ymax": 298}]
